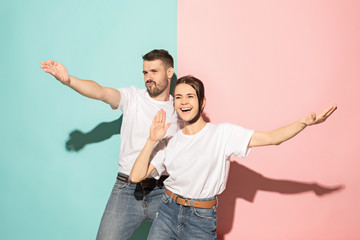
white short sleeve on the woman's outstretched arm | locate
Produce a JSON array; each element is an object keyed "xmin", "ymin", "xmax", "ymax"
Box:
[{"xmin": 224, "ymin": 123, "xmax": 254, "ymax": 158}]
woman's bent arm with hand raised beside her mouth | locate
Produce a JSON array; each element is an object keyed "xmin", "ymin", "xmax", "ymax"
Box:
[{"xmin": 130, "ymin": 109, "xmax": 170, "ymax": 183}]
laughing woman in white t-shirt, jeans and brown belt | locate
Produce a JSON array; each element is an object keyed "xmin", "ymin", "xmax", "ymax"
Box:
[{"xmin": 130, "ymin": 76, "xmax": 336, "ymax": 240}]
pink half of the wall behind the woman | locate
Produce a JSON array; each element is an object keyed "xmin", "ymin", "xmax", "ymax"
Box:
[{"xmin": 177, "ymin": 0, "xmax": 360, "ymax": 240}]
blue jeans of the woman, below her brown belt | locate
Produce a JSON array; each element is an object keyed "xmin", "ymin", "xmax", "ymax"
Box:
[{"xmin": 148, "ymin": 193, "xmax": 217, "ymax": 240}]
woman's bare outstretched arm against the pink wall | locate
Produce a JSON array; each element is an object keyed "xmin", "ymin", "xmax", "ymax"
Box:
[{"xmin": 249, "ymin": 105, "xmax": 337, "ymax": 147}]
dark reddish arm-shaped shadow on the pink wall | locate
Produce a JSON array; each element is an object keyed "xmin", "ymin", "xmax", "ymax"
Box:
[{"xmin": 217, "ymin": 161, "xmax": 344, "ymax": 240}]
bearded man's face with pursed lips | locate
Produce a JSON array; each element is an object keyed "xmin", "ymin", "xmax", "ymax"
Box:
[{"xmin": 143, "ymin": 60, "xmax": 169, "ymax": 97}]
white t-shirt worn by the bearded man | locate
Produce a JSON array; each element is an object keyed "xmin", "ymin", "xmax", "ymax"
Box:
[{"xmin": 118, "ymin": 87, "xmax": 181, "ymax": 175}]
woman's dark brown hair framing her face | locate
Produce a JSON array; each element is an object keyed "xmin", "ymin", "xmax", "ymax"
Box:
[{"xmin": 174, "ymin": 75, "xmax": 205, "ymax": 124}]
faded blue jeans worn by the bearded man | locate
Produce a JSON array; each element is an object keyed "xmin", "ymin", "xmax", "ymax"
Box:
[{"xmin": 96, "ymin": 174, "xmax": 165, "ymax": 240}]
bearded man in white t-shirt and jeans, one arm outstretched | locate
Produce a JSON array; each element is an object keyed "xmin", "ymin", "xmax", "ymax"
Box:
[{"xmin": 41, "ymin": 50, "xmax": 179, "ymax": 240}]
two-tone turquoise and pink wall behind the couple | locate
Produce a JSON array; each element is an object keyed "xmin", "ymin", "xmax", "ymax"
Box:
[{"xmin": 0, "ymin": 0, "xmax": 360, "ymax": 240}]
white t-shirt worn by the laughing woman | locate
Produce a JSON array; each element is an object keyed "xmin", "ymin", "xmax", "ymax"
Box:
[{"xmin": 151, "ymin": 123, "xmax": 254, "ymax": 198}]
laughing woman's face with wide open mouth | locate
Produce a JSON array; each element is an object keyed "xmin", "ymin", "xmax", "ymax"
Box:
[{"xmin": 174, "ymin": 83, "xmax": 199, "ymax": 122}]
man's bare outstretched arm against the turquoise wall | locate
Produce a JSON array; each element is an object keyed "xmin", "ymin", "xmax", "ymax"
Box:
[{"xmin": 40, "ymin": 60, "xmax": 121, "ymax": 108}]
